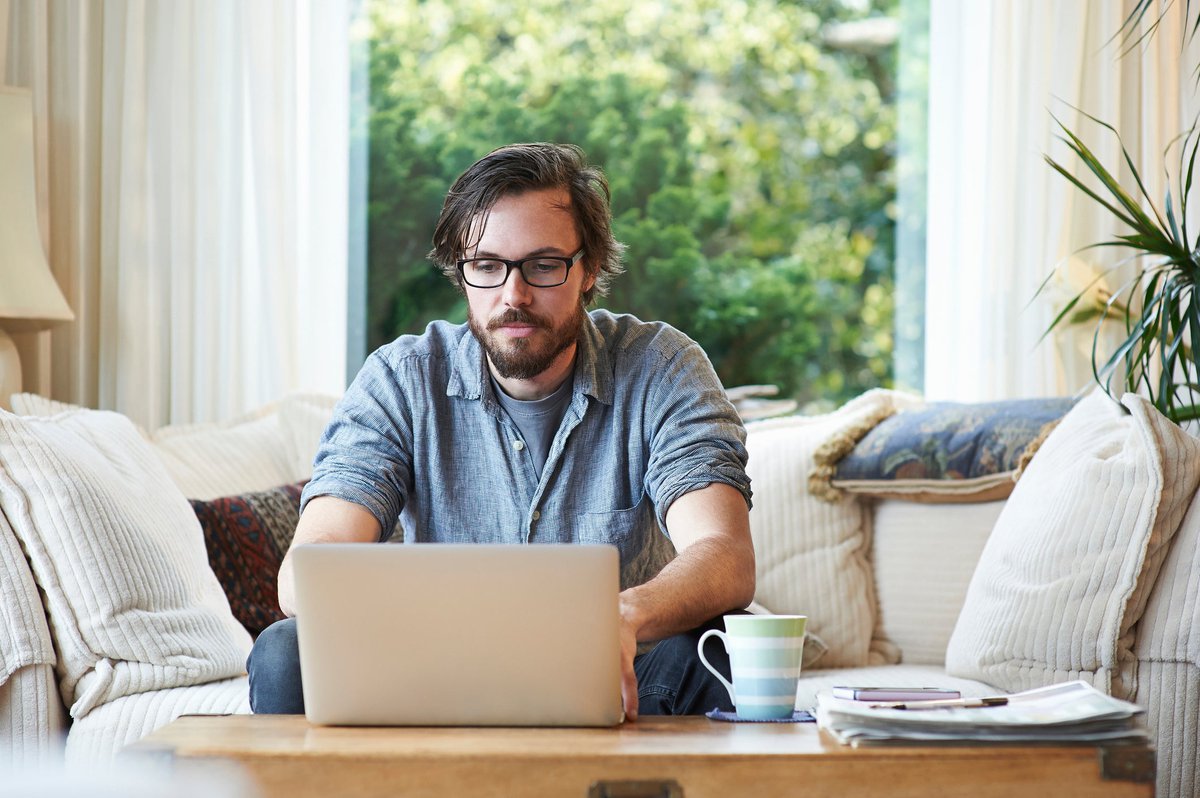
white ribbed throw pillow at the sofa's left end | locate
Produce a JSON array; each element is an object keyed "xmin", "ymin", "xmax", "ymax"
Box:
[{"xmin": 0, "ymin": 410, "xmax": 251, "ymax": 719}]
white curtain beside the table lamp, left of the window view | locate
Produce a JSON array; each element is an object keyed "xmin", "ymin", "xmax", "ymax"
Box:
[{"xmin": 0, "ymin": 0, "xmax": 349, "ymax": 428}]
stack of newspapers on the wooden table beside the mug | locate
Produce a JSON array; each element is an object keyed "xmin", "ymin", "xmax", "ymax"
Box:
[{"xmin": 816, "ymin": 682, "xmax": 1148, "ymax": 748}]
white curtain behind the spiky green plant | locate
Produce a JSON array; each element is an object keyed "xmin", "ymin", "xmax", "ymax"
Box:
[{"xmin": 925, "ymin": 0, "xmax": 1200, "ymax": 401}]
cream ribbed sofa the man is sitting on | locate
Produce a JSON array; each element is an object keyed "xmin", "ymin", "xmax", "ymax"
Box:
[{"xmin": 0, "ymin": 392, "xmax": 1200, "ymax": 796}]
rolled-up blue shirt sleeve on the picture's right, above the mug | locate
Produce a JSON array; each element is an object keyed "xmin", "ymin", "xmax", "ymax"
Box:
[{"xmin": 646, "ymin": 343, "xmax": 751, "ymax": 529}]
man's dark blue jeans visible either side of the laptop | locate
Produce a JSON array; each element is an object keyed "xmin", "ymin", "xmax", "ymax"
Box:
[{"xmin": 246, "ymin": 609, "xmax": 733, "ymax": 715}]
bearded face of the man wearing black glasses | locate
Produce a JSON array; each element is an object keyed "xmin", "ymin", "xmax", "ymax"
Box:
[{"xmin": 463, "ymin": 188, "xmax": 593, "ymax": 379}]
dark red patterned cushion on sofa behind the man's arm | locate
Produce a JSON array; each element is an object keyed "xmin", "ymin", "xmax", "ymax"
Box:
[{"xmin": 191, "ymin": 482, "xmax": 304, "ymax": 636}]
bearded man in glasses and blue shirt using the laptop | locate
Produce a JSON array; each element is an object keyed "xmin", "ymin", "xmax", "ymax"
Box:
[{"xmin": 247, "ymin": 144, "xmax": 755, "ymax": 719}]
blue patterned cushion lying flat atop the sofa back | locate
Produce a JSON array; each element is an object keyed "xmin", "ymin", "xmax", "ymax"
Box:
[{"xmin": 832, "ymin": 398, "xmax": 1075, "ymax": 502}]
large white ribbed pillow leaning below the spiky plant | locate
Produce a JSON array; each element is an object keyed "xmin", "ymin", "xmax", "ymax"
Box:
[{"xmin": 946, "ymin": 391, "xmax": 1200, "ymax": 698}]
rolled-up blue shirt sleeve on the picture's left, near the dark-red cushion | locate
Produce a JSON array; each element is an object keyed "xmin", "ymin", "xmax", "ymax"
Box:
[{"xmin": 300, "ymin": 352, "xmax": 413, "ymax": 540}]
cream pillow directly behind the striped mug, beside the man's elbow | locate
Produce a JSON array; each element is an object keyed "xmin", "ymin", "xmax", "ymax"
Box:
[{"xmin": 746, "ymin": 390, "xmax": 910, "ymax": 667}]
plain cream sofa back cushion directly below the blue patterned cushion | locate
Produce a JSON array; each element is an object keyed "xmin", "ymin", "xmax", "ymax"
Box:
[{"xmin": 871, "ymin": 499, "xmax": 1004, "ymax": 665}]
